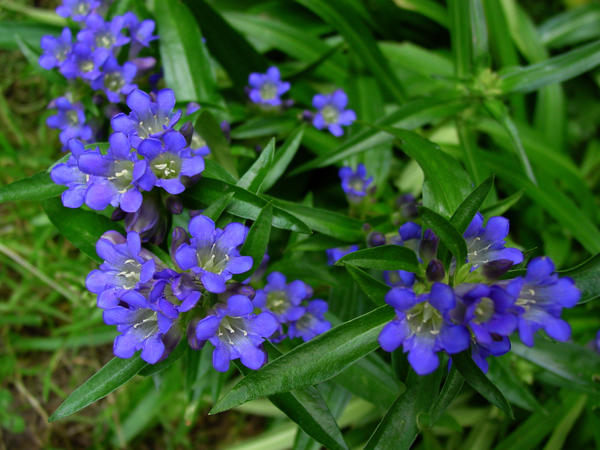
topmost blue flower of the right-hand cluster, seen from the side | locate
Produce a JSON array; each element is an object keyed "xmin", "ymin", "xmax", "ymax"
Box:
[{"xmin": 464, "ymin": 213, "xmax": 523, "ymax": 270}]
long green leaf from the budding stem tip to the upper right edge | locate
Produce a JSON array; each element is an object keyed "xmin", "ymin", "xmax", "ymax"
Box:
[{"xmin": 500, "ymin": 41, "xmax": 600, "ymax": 93}]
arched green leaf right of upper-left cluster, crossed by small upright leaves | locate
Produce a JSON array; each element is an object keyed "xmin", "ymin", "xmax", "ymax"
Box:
[{"xmin": 182, "ymin": 178, "xmax": 310, "ymax": 233}]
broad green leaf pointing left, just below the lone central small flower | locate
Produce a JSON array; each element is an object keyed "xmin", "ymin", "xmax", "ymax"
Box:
[{"xmin": 264, "ymin": 196, "xmax": 363, "ymax": 242}]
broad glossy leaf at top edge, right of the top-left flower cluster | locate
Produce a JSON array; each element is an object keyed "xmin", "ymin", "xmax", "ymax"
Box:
[{"xmin": 154, "ymin": 0, "xmax": 220, "ymax": 103}]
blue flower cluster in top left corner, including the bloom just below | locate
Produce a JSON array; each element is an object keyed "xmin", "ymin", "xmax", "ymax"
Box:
[{"xmin": 39, "ymin": 0, "xmax": 158, "ymax": 147}]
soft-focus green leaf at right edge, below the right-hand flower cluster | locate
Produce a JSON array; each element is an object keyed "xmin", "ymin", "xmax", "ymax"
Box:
[{"xmin": 512, "ymin": 339, "xmax": 600, "ymax": 394}]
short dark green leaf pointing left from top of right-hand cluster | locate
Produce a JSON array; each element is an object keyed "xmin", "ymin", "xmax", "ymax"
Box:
[{"xmin": 336, "ymin": 245, "xmax": 419, "ymax": 272}]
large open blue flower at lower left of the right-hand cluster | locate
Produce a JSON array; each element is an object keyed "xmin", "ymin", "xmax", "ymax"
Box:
[{"xmin": 379, "ymin": 283, "xmax": 469, "ymax": 375}]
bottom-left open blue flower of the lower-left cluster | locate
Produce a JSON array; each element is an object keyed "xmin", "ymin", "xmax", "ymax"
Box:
[{"xmin": 103, "ymin": 291, "xmax": 180, "ymax": 364}]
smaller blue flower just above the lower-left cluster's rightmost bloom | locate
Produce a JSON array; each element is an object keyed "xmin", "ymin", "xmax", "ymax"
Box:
[{"xmin": 253, "ymin": 272, "xmax": 312, "ymax": 324}]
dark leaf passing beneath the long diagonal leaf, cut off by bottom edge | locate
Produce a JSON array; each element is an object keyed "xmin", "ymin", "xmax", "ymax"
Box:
[{"xmin": 233, "ymin": 356, "xmax": 348, "ymax": 449}]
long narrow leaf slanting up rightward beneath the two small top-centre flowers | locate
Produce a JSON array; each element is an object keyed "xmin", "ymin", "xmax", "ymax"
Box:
[{"xmin": 290, "ymin": 98, "xmax": 466, "ymax": 175}]
